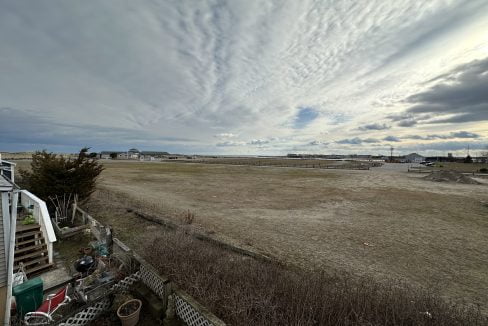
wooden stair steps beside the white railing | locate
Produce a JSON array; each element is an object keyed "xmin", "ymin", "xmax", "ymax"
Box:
[{"xmin": 14, "ymin": 224, "xmax": 53, "ymax": 277}]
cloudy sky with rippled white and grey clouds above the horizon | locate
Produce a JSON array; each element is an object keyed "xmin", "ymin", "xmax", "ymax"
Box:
[{"xmin": 0, "ymin": 0, "xmax": 488, "ymax": 155}]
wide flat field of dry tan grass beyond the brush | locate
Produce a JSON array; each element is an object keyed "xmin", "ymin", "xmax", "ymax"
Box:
[{"xmin": 90, "ymin": 161, "xmax": 488, "ymax": 310}]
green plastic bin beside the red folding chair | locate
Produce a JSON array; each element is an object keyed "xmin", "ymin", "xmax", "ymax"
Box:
[{"xmin": 12, "ymin": 277, "xmax": 43, "ymax": 319}]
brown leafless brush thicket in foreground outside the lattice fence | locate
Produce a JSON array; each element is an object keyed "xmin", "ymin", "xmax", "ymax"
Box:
[{"xmin": 145, "ymin": 232, "xmax": 488, "ymax": 326}]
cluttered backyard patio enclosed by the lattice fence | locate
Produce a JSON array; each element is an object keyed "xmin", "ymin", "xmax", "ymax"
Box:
[{"xmin": 12, "ymin": 208, "xmax": 225, "ymax": 326}]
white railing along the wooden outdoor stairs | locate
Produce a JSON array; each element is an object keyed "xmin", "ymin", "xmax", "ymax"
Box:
[{"xmin": 20, "ymin": 190, "xmax": 56, "ymax": 263}]
